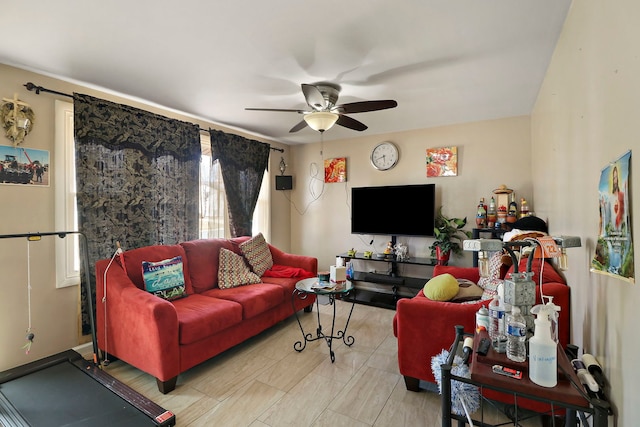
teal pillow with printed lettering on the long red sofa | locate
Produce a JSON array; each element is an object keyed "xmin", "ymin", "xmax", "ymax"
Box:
[{"xmin": 142, "ymin": 256, "xmax": 187, "ymax": 301}]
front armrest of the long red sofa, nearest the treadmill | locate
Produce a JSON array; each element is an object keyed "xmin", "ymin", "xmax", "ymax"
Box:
[{"xmin": 96, "ymin": 260, "xmax": 180, "ymax": 381}]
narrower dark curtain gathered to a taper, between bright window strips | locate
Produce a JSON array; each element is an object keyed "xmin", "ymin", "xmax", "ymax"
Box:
[{"xmin": 209, "ymin": 129, "xmax": 270, "ymax": 237}]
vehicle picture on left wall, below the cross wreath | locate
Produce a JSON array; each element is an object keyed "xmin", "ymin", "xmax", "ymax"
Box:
[{"xmin": 0, "ymin": 145, "xmax": 51, "ymax": 187}]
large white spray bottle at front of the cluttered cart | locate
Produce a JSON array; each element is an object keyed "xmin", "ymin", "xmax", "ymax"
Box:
[{"xmin": 529, "ymin": 305, "xmax": 558, "ymax": 387}]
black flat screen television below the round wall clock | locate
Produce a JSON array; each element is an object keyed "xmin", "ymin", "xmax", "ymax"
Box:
[{"xmin": 351, "ymin": 184, "xmax": 436, "ymax": 237}]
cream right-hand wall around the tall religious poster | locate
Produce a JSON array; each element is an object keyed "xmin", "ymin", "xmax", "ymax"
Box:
[{"xmin": 532, "ymin": 0, "xmax": 640, "ymax": 426}]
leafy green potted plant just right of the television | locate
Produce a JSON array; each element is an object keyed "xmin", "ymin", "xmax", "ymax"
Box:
[{"xmin": 430, "ymin": 206, "xmax": 471, "ymax": 265}]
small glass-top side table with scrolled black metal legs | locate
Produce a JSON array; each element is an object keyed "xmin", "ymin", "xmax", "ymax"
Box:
[{"xmin": 291, "ymin": 277, "xmax": 355, "ymax": 363}]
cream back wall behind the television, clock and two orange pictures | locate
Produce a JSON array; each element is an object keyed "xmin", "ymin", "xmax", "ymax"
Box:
[{"xmin": 291, "ymin": 117, "xmax": 536, "ymax": 269}]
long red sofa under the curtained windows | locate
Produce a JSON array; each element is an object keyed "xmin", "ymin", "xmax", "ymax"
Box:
[{"xmin": 96, "ymin": 237, "xmax": 318, "ymax": 393}]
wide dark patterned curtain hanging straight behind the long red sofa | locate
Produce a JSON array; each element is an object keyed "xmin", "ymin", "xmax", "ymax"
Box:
[{"xmin": 73, "ymin": 94, "xmax": 200, "ymax": 335}]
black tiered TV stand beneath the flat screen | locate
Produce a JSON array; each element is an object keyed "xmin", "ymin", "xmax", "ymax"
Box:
[{"xmin": 338, "ymin": 251, "xmax": 437, "ymax": 310}]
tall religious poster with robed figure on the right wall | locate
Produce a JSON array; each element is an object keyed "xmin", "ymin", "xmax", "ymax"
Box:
[{"xmin": 591, "ymin": 150, "xmax": 635, "ymax": 283}]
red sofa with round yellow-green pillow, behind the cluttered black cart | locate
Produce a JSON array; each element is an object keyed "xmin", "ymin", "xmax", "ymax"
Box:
[{"xmin": 393, "ymin": 259, "xmax": 571, "ymax": 391}]
